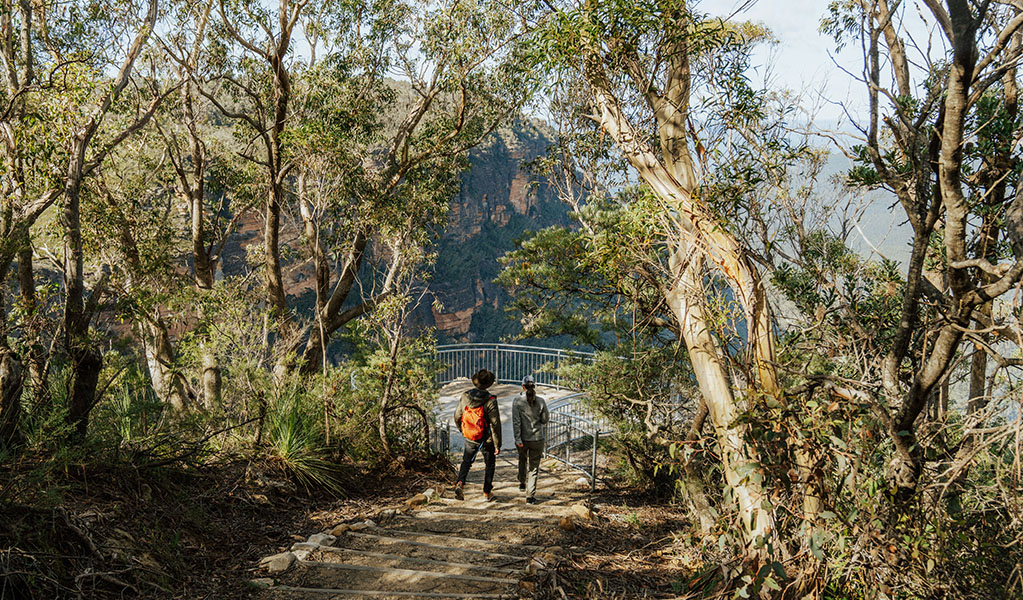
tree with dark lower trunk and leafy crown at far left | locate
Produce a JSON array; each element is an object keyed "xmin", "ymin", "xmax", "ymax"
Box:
[{"xmin": 0, "ymin": 0, "xmax": 167, "ymax": 441}]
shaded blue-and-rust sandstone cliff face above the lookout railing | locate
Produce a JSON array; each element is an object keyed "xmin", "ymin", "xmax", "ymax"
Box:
[{"xmin": 420, "ymin": 122, "xmax": 567, "ymax": 342}]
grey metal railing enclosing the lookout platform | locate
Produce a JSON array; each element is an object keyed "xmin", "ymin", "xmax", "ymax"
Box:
[{"xmin": 432, "ymin": 343, "xmax": 612, "ymax": 491}]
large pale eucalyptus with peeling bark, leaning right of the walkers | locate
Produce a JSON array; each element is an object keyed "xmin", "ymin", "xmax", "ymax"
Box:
[{"xmin": 537, "ymin": 0, "xmax": 789, "ymax": 552}]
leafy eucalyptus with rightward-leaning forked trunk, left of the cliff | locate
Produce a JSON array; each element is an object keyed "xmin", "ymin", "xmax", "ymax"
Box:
[{"xmin": 204, "ymin": 0, "xmax": 530, "ymax": 370}]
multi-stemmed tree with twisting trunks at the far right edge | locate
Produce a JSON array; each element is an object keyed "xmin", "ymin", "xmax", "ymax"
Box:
[{"xmin": 824, "ymin": 0, "xmax": 1023, "ymax": 499}]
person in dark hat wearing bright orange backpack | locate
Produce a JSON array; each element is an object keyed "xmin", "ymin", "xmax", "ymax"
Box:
[{"xmin": 454, "ymin": 369, "xmax": 501, "ymax": 502}]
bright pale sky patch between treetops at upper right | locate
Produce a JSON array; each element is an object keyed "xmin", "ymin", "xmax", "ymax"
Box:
[{"xmin": 697, "ymin": 0, "xmax": 865, "ymax": 125}]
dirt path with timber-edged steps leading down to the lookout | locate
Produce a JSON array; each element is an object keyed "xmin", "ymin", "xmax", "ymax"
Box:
[{"xmin": 253, "ymin": 452, "xmax": 592, "ymax": 600}]
